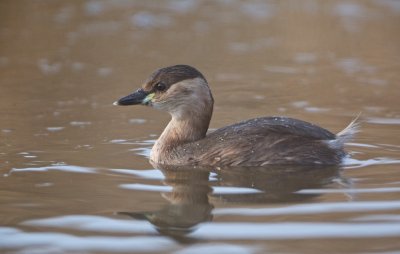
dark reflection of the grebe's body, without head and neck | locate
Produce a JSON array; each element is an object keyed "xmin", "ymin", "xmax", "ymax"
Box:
[{"xmin": 213, "ymin": 165, "xmax": 340, "ymax": 203}]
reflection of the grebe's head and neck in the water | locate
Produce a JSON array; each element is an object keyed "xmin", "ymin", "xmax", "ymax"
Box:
[{"xmin": 119, "ymin": 166, "xmax": 214, "ymax": 237}]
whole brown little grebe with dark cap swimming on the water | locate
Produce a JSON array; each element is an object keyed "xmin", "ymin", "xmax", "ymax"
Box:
[{"xmin": 114, "ymin": 65, "xmax": 358, "ymax": 166}]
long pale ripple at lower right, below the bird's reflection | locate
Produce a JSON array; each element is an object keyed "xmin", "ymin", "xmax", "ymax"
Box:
[{"xmin": 190, "ymin": 222, "xmax": 400, "ymax": 240}]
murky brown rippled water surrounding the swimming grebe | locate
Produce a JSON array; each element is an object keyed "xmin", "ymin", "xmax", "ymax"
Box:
[{"xmin": 0, "ymin": 0, "xmax": 400, "ymax": 253}]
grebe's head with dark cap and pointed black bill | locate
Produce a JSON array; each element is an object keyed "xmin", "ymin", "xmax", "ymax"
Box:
[{"xmin": 114, "ymin": 65, "xmax": 214, "ymax": 119}]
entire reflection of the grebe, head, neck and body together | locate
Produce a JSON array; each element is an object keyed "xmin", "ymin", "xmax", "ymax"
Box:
[{"xmin": 118, "ymin": 165, "xmax": 340, "ymax": 241}]
